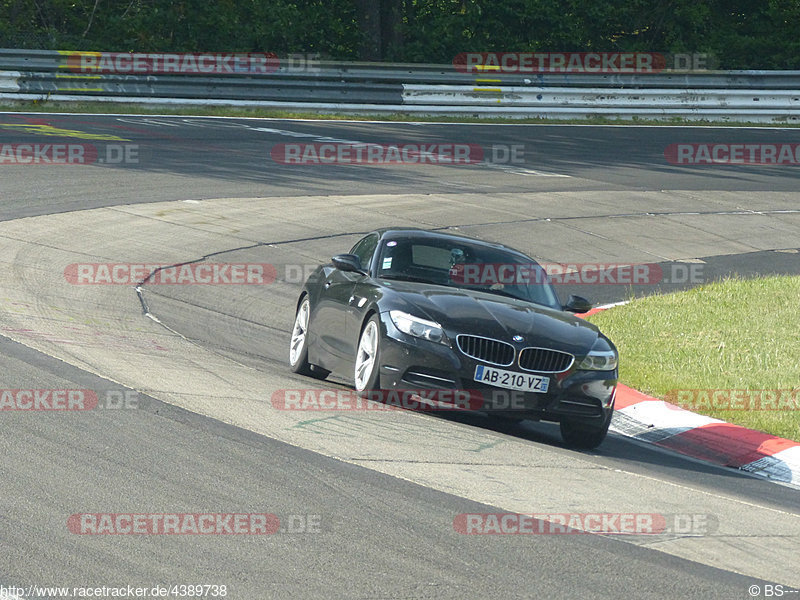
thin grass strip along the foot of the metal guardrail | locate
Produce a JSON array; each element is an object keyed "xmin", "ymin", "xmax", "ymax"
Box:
[{"xmin": 0, "ymin": 101, "xmax": 800, "ymax": 127}]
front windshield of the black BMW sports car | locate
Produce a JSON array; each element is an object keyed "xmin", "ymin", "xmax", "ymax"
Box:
[{"xmin": 377, "ymin": 238, "xmax": 560, "ymax": 308}]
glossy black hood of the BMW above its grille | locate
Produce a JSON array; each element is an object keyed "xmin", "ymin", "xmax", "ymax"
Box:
[{"xmin": 384, "ymin": 281, "xmax": 600, "ymax": 355}]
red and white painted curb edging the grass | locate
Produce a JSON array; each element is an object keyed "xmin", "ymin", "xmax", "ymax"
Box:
[{"xmin": 586, "ymin": 303, "xmax": 800, "ymax": 487}]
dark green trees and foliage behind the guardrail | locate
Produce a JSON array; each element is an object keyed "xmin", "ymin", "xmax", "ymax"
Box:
[{"xmin": 0, "ymin": 0, "xmax": 800, "ymax": 69}]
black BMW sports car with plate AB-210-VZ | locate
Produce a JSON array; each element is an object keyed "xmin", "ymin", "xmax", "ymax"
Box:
[{"xmin": 289, "ymin": 228, "xmax": 618, "ymax": 448}]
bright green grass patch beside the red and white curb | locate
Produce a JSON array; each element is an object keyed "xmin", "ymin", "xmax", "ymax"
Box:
[{"xmin": 589, "ymin": 276, "xmax": 800, "ymax": 441}]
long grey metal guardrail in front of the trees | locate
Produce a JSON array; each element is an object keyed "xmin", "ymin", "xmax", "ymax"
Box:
[{"xmin": 0, "ymin": 49, "xmax": 800, "ymax": 123}]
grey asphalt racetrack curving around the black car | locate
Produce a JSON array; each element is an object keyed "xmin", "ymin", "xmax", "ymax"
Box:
[{"xmin": 0, "ymin": 113, "xmax": 800, "ymax": 600}]
